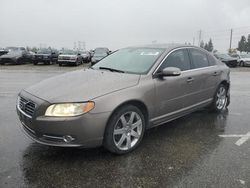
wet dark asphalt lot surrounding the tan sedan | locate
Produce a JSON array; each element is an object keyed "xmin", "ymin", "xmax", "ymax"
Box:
[{"xmin": 0, "ymin": 65, "xmax": 250, "ymax": 188}]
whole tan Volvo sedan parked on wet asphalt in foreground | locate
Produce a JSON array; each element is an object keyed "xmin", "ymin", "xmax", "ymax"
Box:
[{"xmin": 17, "ymin": 45, "xmax": 230, "ymax": 154}]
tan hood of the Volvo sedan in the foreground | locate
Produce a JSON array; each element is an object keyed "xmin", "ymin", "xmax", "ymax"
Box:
[{"xmin": 25, "ymin": 69, "xmax": 140, "ymax": 103}]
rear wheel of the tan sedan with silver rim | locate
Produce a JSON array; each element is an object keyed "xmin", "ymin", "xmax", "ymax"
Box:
[{"xmin": 211, "ymin": 84, "xmax": 229, "ymax": 113}]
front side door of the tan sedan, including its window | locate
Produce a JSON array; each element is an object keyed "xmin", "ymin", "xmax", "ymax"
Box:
[{"xmin": 154, "ymin": 49, "xmax": 193, "ymax": 124}]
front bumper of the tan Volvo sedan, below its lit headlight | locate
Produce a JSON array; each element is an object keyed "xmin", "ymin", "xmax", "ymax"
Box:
[{"xmin": 17, "ymin": 91, "xmax": 110, "ymax": 148}]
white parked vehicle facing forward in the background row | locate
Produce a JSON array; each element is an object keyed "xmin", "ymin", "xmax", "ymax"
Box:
[{"xmin": 57, "ymin": 50, "xmax": 83, "ymax": 66}]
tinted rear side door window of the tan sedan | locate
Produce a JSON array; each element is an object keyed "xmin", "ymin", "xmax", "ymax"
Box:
[{"xmin": 190, "ymin": 49, "xmax": 209, "ymax": 68}]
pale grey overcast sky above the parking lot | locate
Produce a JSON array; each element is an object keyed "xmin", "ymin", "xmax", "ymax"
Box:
[{"xmin": 0, "ymin": 0, "xmax": 250, "ymax": 50}]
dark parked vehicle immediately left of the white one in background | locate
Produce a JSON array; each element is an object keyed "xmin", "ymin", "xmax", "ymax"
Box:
[{"xmin": 33, "ymin": 48, "xmax": 59, "ymax": 65}]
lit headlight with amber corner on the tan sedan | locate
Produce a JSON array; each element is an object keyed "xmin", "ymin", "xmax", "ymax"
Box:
[{"xmin": 45, "ymin": 102, "xmax": 95, "ymax": 117}]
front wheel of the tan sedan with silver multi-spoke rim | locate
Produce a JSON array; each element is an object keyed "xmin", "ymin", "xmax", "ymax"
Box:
[{"xmin": 104, "ymin": 105, "xmax": 145, "ymax": 155}]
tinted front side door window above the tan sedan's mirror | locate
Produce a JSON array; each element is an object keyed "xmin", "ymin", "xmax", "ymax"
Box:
[{"xmin": 159, "ymin": 49, "xmax": 190, "ymax": 71}]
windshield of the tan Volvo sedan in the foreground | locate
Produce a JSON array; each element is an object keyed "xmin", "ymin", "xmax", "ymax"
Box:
[{"xmin": 92, "ymin": 48, "xmax": 164, "ymax": 74}]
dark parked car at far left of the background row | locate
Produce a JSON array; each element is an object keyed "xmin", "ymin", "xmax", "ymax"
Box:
[{"xmin": 0, "ymin": 47, "xmax": 32, "ymax": 65}]
